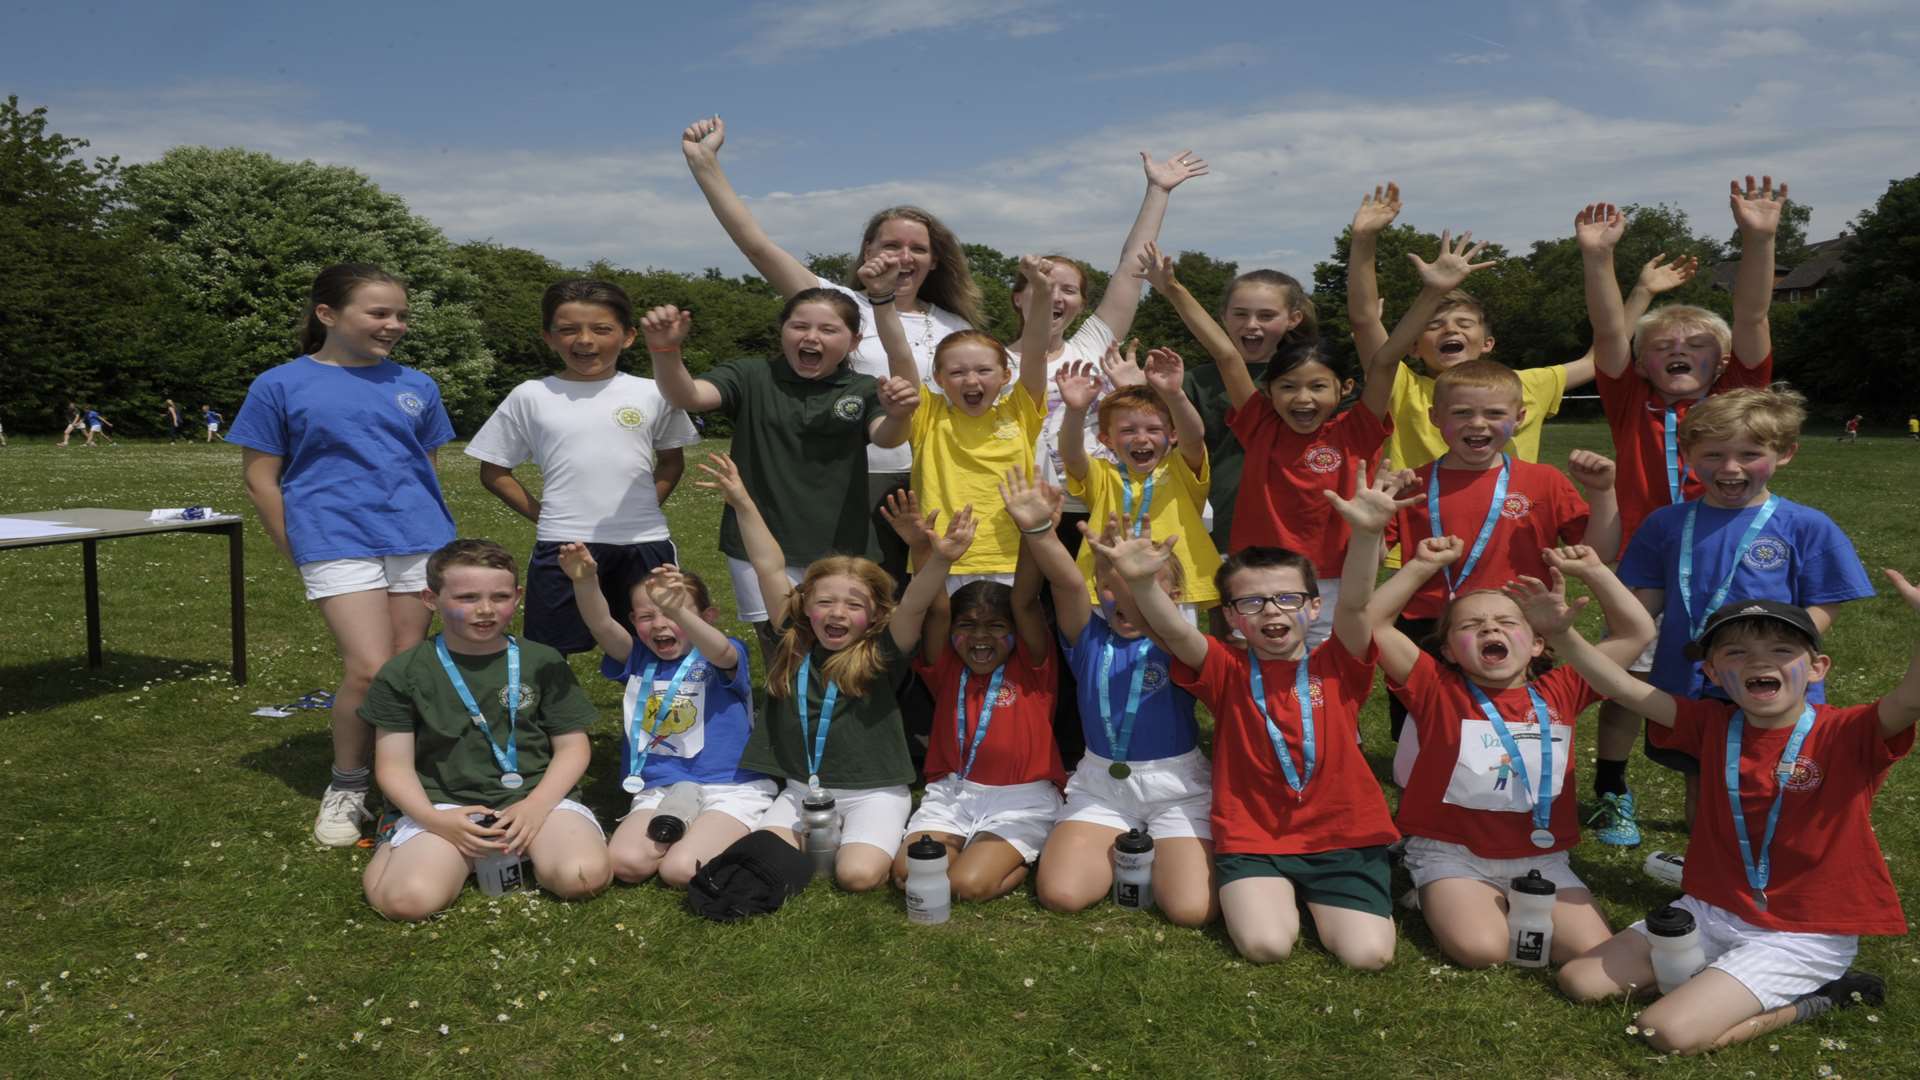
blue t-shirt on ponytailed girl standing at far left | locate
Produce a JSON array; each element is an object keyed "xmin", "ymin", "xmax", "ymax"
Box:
[{"xmin": 227, "ymin": 356, "xmax": 453, "ymax": 563}]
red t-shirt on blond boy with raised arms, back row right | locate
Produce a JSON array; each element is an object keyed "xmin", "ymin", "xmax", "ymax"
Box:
[{"xmin": 1594, "ymin": 354, "xmax": 1774, "ymax": 552}]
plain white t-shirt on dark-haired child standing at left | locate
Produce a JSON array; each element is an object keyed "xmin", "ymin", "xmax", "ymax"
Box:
[{"xmin": 467, "ymin": 371, "xmax": 701, "ymax": 544}]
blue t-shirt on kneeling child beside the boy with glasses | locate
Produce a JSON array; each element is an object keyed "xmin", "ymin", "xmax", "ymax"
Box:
[{"xmin": 1060, "ymin": 611, "xmax": 1200, "ymax": 761}]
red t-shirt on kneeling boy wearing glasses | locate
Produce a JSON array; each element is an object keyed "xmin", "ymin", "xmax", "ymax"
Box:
[{"xmin": 1171, "ymin": 638, "xmax": 1400, "ymax": 855}]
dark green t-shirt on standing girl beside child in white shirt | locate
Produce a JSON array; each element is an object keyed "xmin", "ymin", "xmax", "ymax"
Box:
[{"xmin": 701, "ymin": 359, "xmax": 883, "ymax": 567}]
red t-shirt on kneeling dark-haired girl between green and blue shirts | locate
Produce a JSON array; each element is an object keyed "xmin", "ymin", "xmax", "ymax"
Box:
[{"xmin": 914, "ymin": 646, "xmax": 1068, "ymax": 788}]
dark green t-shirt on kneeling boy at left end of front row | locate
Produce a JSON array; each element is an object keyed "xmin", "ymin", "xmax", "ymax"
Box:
[{"xmin": 359, "ymin": 638, "xmax": 597, "ymax": 809}]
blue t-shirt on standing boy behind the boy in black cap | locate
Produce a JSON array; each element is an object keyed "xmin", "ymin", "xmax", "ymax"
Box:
[{"xmin": 1620, "ymin": 500, "xmax": 1874, "ymax": 703}]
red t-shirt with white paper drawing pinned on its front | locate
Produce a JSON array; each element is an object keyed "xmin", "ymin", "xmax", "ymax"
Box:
[{"xmin": 1386, "ymin": 651, "xmax": 1599, "ymax": 859}]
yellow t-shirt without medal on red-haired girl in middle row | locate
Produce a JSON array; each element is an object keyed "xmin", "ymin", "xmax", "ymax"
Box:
[{"xmin": 910, "ymin": 382, "xmax": 1046, "ymax": 575}]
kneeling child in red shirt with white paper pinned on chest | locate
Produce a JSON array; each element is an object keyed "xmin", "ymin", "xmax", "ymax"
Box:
[{"xmin": 1336, "ymin": 500, "xmax": 1653, "ymax": 969}]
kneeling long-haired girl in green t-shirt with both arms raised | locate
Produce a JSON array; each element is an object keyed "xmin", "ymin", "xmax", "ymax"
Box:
[{"xmin": 695, "ymin": 454, "xmax": 973, "ymax": 892}]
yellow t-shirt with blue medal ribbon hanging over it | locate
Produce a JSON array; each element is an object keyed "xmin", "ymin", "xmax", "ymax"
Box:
[{"xmin": 1068, "ymin": 448, "xmax": 1219, "ymax": 607}]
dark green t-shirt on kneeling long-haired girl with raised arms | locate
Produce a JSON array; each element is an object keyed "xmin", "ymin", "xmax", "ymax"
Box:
[{"xmin": 739, "ymin": 632, "xmax": 914, "ymax": 790}]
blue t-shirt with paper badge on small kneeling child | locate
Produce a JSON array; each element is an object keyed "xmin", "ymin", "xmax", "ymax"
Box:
[{"xmin": 601, "ymin": 638, "xmax": 766, "ymax": 788}]
